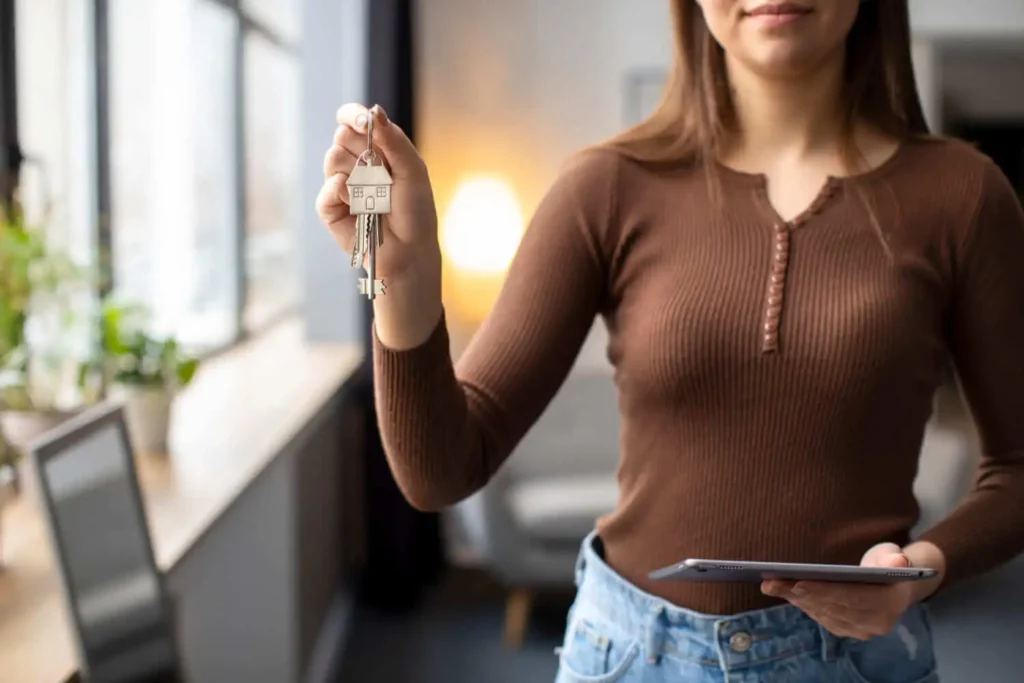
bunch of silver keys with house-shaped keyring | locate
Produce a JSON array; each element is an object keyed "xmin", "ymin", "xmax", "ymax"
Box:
[{"xmin": 345, "ymin": 112, "xmax": 392, "ymax": 301}]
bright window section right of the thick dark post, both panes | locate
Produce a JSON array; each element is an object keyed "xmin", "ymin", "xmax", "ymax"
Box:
[{"xmin": 109, "ymin": 0, "xmax": 301, "ymax": 349}]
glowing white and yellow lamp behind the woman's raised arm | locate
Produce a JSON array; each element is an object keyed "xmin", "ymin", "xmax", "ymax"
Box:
[{"xmin": 440, "ymin": 177, "xmax": 523, "ymax": 324}]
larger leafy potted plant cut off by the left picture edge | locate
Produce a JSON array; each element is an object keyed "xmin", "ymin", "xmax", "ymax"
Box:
[{"xmin": 0, "ymin": 207, "xmax": 88, "ymax": 481}]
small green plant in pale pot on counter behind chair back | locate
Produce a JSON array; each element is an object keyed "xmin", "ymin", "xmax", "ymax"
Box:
[{"xmin": 80, "ymin": 301, "xmax": 199, "ymax": 454}]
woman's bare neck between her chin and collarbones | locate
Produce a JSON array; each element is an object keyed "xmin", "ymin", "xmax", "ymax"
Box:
[{"xmin": 728, "ymin": 52, "xmax": 844, "ymax": 161}]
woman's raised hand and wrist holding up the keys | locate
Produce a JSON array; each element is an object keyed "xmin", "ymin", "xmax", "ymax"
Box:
[{"xmin": 316, "ymin": 103, "xmax": 443, "ymax": 349}]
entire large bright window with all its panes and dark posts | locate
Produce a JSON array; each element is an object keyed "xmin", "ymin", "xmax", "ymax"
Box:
[{"xmin": 15, "ymin": 0, "xmax": 303, "ymax": 360}]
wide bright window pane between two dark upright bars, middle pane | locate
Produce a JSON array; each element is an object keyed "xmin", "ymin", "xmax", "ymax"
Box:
[{"xmin": 110, "ymin": 0, "xmax": 239, "ymax": 348}]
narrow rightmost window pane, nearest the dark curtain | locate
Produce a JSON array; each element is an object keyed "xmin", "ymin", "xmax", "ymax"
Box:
[{"xmin": 245, "ymin": 34, "xmax": 301, "ymax": 330}]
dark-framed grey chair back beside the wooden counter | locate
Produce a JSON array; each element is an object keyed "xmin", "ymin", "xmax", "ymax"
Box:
[{"xmin": 31, "ymin": 404, "xmax": 180, "ymax": 683}]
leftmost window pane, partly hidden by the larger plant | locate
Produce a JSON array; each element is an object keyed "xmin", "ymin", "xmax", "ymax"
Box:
[{"xmin": 13, "ymin": 0, "xmax": 96, "ymax": 409}]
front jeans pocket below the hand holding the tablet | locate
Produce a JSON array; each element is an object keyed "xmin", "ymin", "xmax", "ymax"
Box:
[{"xmin": 842, "ymin": 605, "xmax": 939, "ymax": 683}]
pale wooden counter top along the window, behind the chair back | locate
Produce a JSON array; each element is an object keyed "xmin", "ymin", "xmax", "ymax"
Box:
[{"xmin": 0, "ymin": 321, "xmax": 361, "ymax": 683}]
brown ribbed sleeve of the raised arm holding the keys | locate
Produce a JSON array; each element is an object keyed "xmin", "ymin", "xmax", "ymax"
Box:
[{"xmin": 374, "ymin": 154, "xmax": 614, "ymax": 509}]
